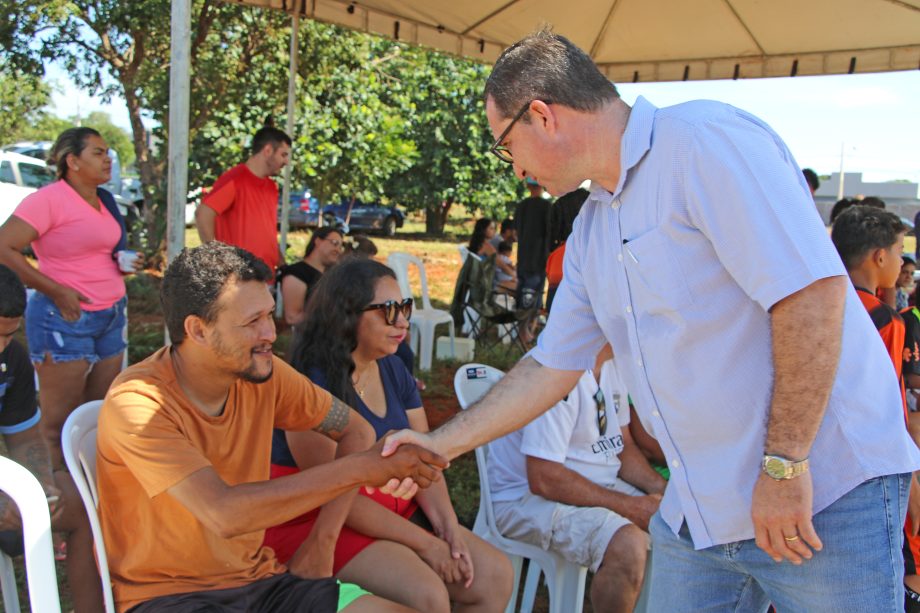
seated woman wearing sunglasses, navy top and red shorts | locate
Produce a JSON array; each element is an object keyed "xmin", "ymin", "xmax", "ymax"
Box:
[{"xmin": 265, "ymin": 259, "xmax": 512, "ymax": 613}]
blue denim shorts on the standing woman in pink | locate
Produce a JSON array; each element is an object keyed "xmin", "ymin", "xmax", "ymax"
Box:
[{"xmin": 26, "ymin": 292, "xmax": 128, "ymax": 364}]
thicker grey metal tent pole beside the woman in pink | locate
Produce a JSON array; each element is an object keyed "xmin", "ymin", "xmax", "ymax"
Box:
[{"xmin": 166, "ymin": 0, "xmax": 192, "ymax": 262}]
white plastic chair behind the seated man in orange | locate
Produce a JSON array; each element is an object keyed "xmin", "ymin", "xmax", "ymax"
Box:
[{"xmin": 61, "ymin": 400, "xmax": 115, "ymax": 613}]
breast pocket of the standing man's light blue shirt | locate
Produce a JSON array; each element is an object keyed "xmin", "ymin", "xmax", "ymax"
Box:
[{"xmin": 623, "ymin": 229, "xmax": 693, "ymax": 314}]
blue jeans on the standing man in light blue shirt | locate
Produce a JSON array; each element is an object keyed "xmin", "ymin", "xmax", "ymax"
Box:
[{"xmin": 648, "ymin": 475, "xmax": 910, "ymax": 613}]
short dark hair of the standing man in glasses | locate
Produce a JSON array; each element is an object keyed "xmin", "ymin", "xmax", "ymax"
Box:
[{"xmin": 484, "ymin": 28, "xmax": 620, "ymax": 123}]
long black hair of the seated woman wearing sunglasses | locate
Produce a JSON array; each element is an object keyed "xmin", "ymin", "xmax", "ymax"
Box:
[{"xmin": 291, "ymin": 257, "xmax": 396, "ymax": 406}]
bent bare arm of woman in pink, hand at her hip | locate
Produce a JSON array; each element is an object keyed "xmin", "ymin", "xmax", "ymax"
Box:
[{"xmin": 0, "ymin": 215, "xmax": 90, "ymax": 321}]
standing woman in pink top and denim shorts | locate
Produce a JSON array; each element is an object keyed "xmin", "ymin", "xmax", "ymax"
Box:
[{"xmin": 0, "ymin": 128, "xmax": 142, "ymax": 468}]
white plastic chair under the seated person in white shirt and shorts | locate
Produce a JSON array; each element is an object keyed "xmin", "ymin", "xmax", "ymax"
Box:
[{"xmin": 454, "ymin": 363, "xmax": 588, "ymax": 613}]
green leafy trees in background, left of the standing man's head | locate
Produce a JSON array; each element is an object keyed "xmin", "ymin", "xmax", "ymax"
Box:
[{"xmin": 0, "ymin": 0, "xmax": 519, "ymax": 237}]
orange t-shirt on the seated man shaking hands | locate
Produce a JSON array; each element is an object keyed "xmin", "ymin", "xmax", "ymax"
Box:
[{"xmin": 96, "ymin": 347, "xmax": 332, "ymax": 611}]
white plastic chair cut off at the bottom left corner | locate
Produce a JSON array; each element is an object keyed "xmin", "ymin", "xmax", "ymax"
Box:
[{"xmin": 0, "ymin": 456, "xmax": 61, "ymax": 613}]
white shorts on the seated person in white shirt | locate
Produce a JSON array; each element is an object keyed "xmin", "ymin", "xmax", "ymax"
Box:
[{"xmin": 492, "ymin": 479, "xmax": 645, "ymax": 572}]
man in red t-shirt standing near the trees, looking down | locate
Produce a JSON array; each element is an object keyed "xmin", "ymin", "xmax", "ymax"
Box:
[{"xmin": 195, "ymin": 127, "xmax": 291, "ymax": 272}]
